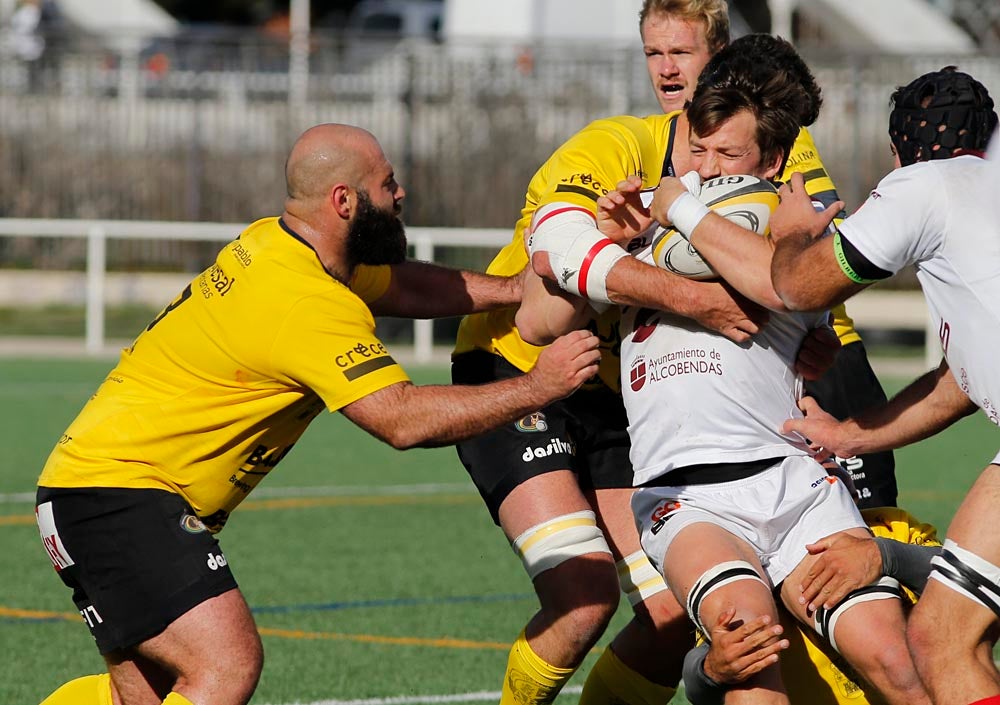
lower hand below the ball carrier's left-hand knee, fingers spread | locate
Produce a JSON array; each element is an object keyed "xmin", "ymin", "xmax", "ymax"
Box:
[{"xmin": 702, "ymin": 607, "xmax": 788, "ymax": 685}]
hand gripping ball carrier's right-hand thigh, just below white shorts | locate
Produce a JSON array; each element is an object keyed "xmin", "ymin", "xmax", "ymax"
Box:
[{"xmin": 799, "ymin": 532, "xmax": 882, "ymax": 612}]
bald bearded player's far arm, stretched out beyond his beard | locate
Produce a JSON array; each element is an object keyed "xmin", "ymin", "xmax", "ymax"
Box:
[{"xmin": 371, "ymin": 260, "xmax": 521, "ymax": 318}]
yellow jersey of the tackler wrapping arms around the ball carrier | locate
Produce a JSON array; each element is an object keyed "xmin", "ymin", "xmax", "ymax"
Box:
[{"xmin": 453, "ymin": 117, "xmax": 860, "ymax": 390}]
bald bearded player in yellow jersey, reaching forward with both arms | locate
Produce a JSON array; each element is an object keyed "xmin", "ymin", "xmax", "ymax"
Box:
[{"xmin": 36, "ymin": 124, "xmax": 599, "ymax": 705}]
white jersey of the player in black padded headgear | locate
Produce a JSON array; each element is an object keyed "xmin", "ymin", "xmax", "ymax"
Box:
[{"xmin": 840, "ymin": 156, "xmax": 1000, "ymax": 424}]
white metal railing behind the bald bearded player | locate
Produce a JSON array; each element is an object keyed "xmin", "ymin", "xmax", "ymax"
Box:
[{"xmin": 0, "ymin": 218, "xmax": 511, "ymax": 362}]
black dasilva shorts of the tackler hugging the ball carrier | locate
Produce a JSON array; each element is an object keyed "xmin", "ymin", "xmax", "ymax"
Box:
[{"xmin": 451, "ymin": 351, "xmax": 632, "ymax": 523}]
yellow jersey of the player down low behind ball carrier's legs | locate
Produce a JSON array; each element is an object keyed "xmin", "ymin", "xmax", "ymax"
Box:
[{"xmin": 779, "ymin": 507, "xmax": 941, "ymax": 705}]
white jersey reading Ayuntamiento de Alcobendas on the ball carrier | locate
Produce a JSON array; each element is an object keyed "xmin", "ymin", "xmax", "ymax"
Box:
[{"xmin": 621, "ymin": 249, "xmax": 828, "ymax": 485}]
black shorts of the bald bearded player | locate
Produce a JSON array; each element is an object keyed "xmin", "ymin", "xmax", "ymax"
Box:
[{"xmin": 36, "ymin": 487, "xmax": 236, "ymax": 654}]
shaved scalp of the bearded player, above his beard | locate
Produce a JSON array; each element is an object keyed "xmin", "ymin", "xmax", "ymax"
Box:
[{"xmin": 285, "ymin": 123, "xmax": 385, "ymax": 201}]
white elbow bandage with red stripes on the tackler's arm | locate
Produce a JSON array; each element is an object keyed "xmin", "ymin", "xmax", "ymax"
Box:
[{"xmin": 528, "ymin": 203, "xmax": 628, "ymax": 304}]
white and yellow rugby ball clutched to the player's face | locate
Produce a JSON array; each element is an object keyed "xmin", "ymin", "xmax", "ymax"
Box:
[{"xmin": 652, "ymin": 175, "xmax": 778, "ymax": 280}]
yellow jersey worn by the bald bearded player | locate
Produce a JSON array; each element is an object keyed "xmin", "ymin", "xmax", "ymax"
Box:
[{"xmin": 38, "ymin": 218, "xmax": 408, "ymax": 531}]
